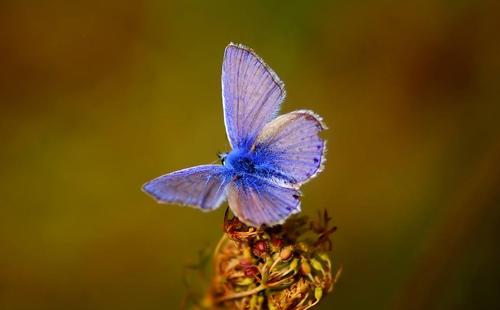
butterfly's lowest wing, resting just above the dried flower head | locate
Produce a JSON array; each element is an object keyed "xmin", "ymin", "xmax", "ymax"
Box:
[{"xmin": 228, "ymin": 176, "xmax": 300, "ymax": 227}]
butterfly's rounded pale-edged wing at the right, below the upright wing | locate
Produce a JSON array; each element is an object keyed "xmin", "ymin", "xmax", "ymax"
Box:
[{"xmin": 254, "ymin": 110, "xmax": 326, "ymax": 186}]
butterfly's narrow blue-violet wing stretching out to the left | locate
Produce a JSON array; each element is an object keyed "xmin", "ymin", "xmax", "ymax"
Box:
[{"xmin": 143, "ymin": 165, "xmax": 227, "ymax": 211}]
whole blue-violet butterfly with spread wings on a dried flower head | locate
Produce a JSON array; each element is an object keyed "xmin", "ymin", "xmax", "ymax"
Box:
[{"xmin": 143, "ymin": 43, "xmax": 326, "ymax": 227}]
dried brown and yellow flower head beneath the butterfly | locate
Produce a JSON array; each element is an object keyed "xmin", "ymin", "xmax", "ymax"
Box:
[{"xmin": 190, "ymin": 211, "xmax": 339, "ymax": 310}]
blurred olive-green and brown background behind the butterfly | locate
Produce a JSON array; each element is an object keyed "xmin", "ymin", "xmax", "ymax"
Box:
[{"xmin": 0, "ymin": 0, "xmax": 500, "ymax": 309}]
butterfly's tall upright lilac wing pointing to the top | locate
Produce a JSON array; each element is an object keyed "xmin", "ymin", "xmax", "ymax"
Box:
[{"xmin": 222, "ymin": 43, "xmax": 286, "ymax": 148}]
